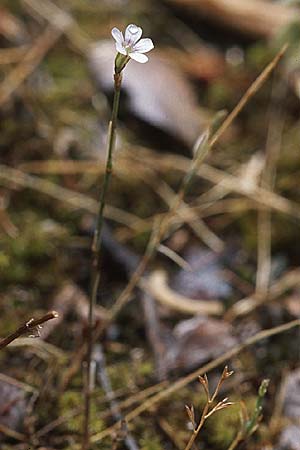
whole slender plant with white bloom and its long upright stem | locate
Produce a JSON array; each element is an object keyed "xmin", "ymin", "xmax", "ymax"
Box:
[{"xmin": 82, "ymin": 24, "xmax": 154, "ymax": 450}]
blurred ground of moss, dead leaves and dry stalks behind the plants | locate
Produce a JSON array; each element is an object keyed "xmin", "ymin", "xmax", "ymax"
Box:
[{"xmin": 0, "ymin": 0, "xmax": 300, "ymax": 450}]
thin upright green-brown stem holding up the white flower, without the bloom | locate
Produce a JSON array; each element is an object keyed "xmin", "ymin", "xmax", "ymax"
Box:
[{"xmin": 82, "ymin": 73, "xmax": 122, "ymax": 450}]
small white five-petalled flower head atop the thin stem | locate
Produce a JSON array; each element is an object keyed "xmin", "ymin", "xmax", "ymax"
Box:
[{"xmin": 111, "ymin": 23, "xmax": 154, "ymax": 63}]
